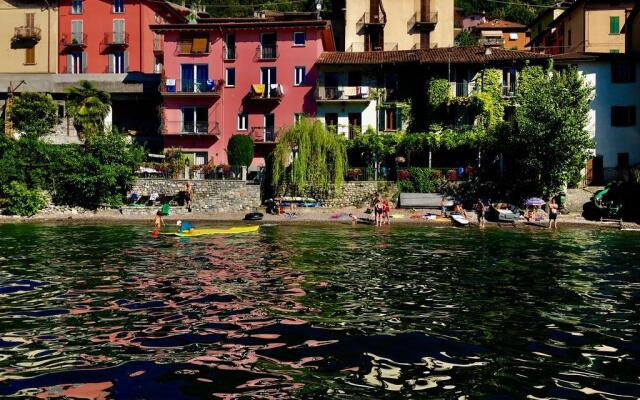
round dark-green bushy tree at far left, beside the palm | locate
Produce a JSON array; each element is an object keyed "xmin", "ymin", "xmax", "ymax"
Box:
[{"xmin": 11, "ymin": 92, "xmax": 58, "ymax": 137}]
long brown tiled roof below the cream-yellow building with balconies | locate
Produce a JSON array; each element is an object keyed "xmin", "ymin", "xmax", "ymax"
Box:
[{"xmin": 318, "ymin": 46, "xmax": 550, "ymax": 65}]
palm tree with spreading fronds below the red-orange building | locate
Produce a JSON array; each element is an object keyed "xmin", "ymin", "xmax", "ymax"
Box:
[{"xmin": 66, "ymin": 81, "xmax": 111, "ymax": 136}]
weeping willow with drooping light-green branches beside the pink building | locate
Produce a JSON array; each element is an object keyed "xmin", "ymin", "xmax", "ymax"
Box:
[{"xmin": 272, "ymin": 119, "xmax": 347, "ymax": 196}]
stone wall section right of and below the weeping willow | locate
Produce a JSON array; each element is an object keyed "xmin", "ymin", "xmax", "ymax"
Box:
[{"xmin": 319, "ymin": 181, "xmax": 397, "ymax": 208}]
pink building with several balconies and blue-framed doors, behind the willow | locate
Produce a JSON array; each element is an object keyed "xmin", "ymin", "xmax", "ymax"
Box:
[{"xmin": 152, "ymin": 16, "xmax": 334, "ymax": 167}]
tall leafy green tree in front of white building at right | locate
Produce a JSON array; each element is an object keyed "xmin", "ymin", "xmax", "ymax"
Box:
[{"xmin": 499, "ymin": 65, "xmax": 593, "ymax": 196}]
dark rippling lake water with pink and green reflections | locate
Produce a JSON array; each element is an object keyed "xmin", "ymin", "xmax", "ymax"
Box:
[{"xmin": 0, "ymin": 225, "xmax": 640, "ymax": 399}]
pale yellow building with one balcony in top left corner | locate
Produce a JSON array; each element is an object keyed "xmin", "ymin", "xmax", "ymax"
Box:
[{"xmin": 0, "ymin": 0, "xmax": 58, "ymax": 74}]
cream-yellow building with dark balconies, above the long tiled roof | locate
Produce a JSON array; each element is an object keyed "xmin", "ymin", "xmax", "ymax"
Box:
[{"xmin": 345, "ymin": 0, "xmax": 454, "ymax": 51}]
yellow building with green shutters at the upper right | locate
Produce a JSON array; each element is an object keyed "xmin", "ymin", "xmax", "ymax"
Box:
[{"xmin": 554, "ymin": 0, "xmax": 636, "ymax": 53}]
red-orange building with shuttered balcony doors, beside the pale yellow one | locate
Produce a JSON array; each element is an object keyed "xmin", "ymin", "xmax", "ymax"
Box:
[{"xmin": 58, "ymin": 0, "xmax": 184, "ymax": 74}]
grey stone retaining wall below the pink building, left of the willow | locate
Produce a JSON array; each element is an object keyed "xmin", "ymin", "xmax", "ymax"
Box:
[{"xmin": 131, "ymin": 178, "xmax": 261, "ymax": 213}]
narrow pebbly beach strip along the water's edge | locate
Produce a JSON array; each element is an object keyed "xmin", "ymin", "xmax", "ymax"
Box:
[{"xmin": 0, "ymin": 208, "xmax": 640, "ymax": 230}]
